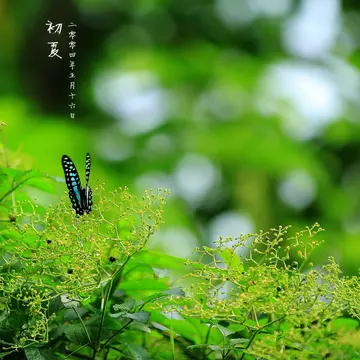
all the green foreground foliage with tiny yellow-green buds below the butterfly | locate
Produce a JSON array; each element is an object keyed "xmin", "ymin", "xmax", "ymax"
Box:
[{"xmin": 0, "ymin": 133, "xmax": 360, "ymax": 360}]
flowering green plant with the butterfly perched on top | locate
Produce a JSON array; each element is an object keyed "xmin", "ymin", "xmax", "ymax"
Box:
[{"xmin": 0, "ymin": 181, "xmax": 183, "ymax": 359}]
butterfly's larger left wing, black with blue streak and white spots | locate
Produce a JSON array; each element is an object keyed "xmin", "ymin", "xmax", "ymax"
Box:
[{"xmin": 61, "ymin": 155, "xmax": 84, "ymax": 215}]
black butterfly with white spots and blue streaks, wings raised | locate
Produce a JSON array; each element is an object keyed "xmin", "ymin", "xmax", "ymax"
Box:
[{"xmin": 61, "ymin": 153, "xmax": 92, "ymax": 215}]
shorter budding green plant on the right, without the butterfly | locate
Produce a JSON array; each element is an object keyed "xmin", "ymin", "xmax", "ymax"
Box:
[{"xmin": 164, "ymin": 224, "xmax": 360, "ymax": 360}]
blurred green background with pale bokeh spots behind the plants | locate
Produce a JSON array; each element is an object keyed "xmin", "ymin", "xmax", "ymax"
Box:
[{"xmin": 0, "ymin": 0, "xmax": 360, "ymax": 274}]
